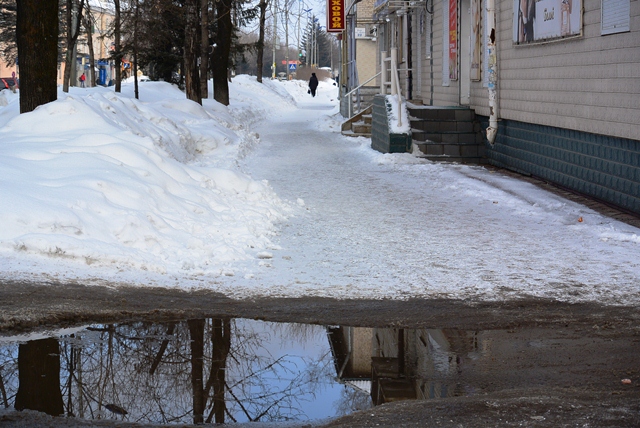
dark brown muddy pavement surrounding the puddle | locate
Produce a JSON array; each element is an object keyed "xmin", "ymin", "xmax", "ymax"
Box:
[{"xmin": 0, "ymin": 282, "xmax": 640, "ymax": 427}]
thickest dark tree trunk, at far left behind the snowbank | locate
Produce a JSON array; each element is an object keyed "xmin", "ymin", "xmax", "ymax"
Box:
[{"xmin": 16, "ymin": 0, "xmax": 58, "ymax": 113}]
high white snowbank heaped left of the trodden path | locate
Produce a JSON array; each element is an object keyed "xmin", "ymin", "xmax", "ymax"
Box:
[{"xmin": 0, "ymin": 77, "xmax": 293, "ymax": 275}]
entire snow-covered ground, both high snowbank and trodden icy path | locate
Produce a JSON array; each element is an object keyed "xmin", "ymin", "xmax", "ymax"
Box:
[{"xmin": 0, "ymin": 76, "xmax": 640, "ymax": 305}]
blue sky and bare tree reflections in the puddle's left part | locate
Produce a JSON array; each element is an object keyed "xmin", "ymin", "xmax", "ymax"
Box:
[{"xmin": 0, "ymin": 319, "xmax": 367, "ymax": 423}]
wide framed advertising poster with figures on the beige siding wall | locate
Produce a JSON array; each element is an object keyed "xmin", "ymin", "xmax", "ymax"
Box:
[{"xmin": 513, "ymin": 0, "xmax": 582, "ymax": 43}]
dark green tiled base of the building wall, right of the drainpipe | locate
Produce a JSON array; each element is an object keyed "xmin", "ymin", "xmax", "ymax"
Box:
[{"xmin": 478, "ymin": 117, "xmax": 640, "ymax": 214}]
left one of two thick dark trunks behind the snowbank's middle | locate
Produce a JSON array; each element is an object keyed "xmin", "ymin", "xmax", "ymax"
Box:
[{"xmin": 184, "ymin": 0, "xmax": 202, "ymax": 104}]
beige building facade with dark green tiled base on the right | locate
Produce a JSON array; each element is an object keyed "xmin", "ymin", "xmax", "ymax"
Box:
[{"xmin": 364, "ymin": 0, "xmax": 640, "ymax": 214}]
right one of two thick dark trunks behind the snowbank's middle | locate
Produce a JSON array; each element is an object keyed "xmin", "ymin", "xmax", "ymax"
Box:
[{"xmin": 211, "ymin": 0, "xmax": 233, "ymax": 106}]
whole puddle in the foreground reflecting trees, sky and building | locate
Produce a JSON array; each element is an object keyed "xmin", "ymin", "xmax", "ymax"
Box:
[{"xmin": 0, "ymin": 319, "xmax": 640, "ymax": 424}]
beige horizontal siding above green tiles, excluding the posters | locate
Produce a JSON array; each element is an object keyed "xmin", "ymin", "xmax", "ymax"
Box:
[{"xmin": 482, "ymin": 0, "xmax": 640, "ymax": 140}]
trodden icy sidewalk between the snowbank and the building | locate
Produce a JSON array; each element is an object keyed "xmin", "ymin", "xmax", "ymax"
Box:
[{"xmin": 230, "ymin": 98, "xmax": 640, "ymax": 304}]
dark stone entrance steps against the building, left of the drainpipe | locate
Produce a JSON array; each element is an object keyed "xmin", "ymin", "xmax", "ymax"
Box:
[{"xmin": 407, "ymin": 104, "xmax": 486, "ymax": 164}]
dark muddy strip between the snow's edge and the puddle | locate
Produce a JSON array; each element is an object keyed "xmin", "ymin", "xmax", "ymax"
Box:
[{"xmin": 0, "ymin": 281, "xmax": 640, "ymax": 335}]
